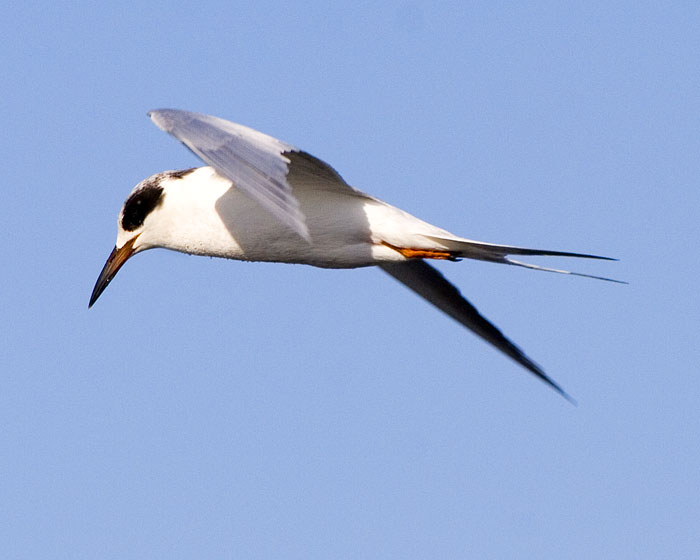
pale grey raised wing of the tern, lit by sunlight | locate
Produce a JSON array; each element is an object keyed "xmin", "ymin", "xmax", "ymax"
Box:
[{"xmin": 148, "ymin": 109, "xmax": 362, "ymax": 241}]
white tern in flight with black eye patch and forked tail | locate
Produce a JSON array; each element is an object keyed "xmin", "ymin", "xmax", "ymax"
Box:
[{"xmin": 89, "ymin": 109, "xmax": 617, "ymax": 400}]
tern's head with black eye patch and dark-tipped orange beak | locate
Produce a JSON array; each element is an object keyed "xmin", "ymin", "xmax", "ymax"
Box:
[{"xmin": 88, "ymin": 169, "xmax": 197, "ymax": 307}]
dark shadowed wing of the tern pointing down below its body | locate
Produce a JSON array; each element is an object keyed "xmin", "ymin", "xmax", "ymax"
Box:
[{"xmin": 379, "ymin": 259, "xmax": 573, "ymax": 402}]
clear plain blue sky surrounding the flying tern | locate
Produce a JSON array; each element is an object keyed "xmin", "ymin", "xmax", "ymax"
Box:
[{"xmin": 0, "ymin": 2, "xmax": 700, "ymax": 559}]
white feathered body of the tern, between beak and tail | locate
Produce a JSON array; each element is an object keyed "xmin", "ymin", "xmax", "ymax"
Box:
[{"xmin": 131, "ymin": 167, "xmax": 466, "ymax": 268}]
